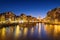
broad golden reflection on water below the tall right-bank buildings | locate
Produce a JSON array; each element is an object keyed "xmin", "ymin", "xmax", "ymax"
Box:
[{"xmin": 44, "ymin": 25, "xmax": 60, "ymax": 37}]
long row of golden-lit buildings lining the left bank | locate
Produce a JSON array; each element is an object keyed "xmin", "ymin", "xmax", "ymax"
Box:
[{"xmin": 0, "ymin": 12, "xmax": 38, "ymax": 23}]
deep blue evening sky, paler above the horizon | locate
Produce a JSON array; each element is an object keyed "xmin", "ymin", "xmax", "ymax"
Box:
[{"xmin": 0, "ymin": 0, "xmax": 60, "ymax": 18}]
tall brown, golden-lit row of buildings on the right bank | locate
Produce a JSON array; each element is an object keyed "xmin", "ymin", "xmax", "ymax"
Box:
[{"xmin": 43, "ymin": 7, "xmax": 60, "ymax": 24}]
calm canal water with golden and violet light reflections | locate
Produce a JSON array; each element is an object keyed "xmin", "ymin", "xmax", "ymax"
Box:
[{"xmin": 0, "ymin": 23, "xmax": 60, "ymax": 40}]
